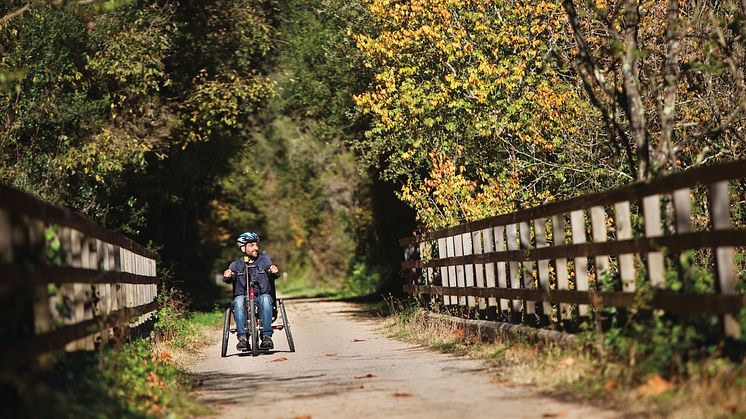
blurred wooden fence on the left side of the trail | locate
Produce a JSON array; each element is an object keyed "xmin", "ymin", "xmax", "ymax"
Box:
[{"xmin": 0, "ymin": 185, "xmax": 158, "ymax": 370}]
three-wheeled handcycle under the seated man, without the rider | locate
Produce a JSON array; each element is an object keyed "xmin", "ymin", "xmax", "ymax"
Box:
[{"xmin": 220, "ymin": 274, "xmax": 295, "ymax": 358}]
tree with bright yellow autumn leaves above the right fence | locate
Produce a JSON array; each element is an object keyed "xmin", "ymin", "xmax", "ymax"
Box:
[{"xmin": 354, "ymin": 0, "xmax": 612, "ymax": 227}]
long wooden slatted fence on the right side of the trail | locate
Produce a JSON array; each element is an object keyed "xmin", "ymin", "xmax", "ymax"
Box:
[{"xmin": 400, "ymin": 161, "xmax": 746, "ymax": 337}]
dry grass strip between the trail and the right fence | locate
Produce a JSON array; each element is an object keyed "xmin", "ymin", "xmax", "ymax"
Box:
[{"xmin": 379, "ymin": 300, "xmax": 746, "ymax": 418}]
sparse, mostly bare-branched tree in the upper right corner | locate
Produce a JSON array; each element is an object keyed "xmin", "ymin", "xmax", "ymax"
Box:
[{"xmin": 563, "ymin": 0, "xmax": 746, "ymax": 180}]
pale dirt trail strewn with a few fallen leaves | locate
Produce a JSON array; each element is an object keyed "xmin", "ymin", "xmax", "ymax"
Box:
[{"xmin": 192, "ymin": 299, "xmax": 616, "ymax": 419}]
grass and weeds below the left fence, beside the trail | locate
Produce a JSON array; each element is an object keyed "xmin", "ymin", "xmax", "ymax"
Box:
[{"xmin": 0, "ymin": 291, "xmax": 222, "ymax": 418}]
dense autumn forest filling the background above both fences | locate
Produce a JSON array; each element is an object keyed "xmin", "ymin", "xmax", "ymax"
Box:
[{"xmin": 0, "ymin": 0, "xmax": 746, "ymax": 294}]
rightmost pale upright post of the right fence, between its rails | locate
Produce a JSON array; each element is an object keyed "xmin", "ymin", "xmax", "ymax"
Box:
[{"xmin": 710, "ymin": 181, "xmax": 741, "ymax": 339}]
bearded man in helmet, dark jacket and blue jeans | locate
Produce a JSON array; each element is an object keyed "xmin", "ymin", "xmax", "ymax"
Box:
[{"xmin": 223, "ymin": 232, "xmax": 280, "ymax": 351}]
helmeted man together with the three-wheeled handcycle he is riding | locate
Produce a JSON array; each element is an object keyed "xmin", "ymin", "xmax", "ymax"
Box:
[{"xmin": 221, "ymin": 232, "xmax": 295, "ymax": 356}]
